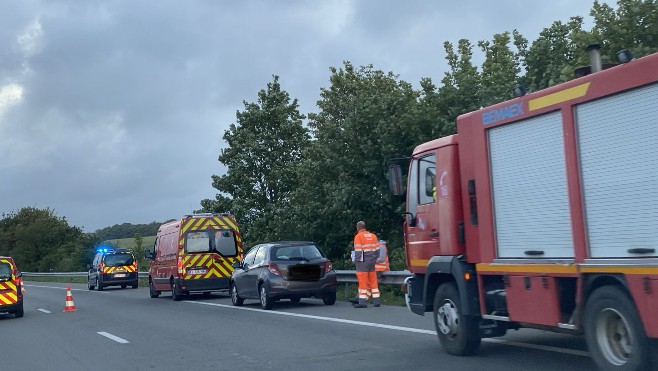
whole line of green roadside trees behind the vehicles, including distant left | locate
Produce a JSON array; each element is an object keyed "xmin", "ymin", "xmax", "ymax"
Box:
[{"xmin": 0, "ymin": 0, "xmax": 658, "ymax": 272}]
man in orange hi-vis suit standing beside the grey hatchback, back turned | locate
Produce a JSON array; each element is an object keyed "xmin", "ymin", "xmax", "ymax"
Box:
[{"xmin": 353, "ymin": 221, "xmax": 380, "ymax": 308}]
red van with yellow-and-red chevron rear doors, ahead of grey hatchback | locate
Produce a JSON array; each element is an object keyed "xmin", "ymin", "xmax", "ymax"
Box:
[{"xmin": 145, "ymin": 214, "xmax": 243, "ymax": 301}]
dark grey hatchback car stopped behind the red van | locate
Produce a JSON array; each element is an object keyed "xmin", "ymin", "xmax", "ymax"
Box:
[{"xmin": 229, "ymin": 241, "xmax": 336, "ymax": 309}]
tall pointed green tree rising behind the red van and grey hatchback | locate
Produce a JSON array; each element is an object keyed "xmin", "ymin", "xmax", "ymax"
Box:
[{"xmin": 201, "ymin": 76, "xmax": 310, "ymax": 242}]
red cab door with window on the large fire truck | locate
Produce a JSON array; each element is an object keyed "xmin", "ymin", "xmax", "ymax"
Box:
[{"xmin": 405, "ymin": 153, "xmax": 440, "ymax": 272}]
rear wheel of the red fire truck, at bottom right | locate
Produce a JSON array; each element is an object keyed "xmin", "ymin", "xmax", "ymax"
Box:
[{"xmin": 583, "ymin": 286, "xmax": 655, "ymax": 370}]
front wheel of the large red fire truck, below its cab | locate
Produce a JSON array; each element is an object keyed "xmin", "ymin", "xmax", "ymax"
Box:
[{"xmin": 434, "ymin": 282, "xmax": 482, "ymax": 356}]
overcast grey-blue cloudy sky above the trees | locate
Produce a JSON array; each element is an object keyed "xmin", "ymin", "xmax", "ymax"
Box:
[{"xmin": 0, "ymin": 0, "xmax": 614, "ymax": 232}]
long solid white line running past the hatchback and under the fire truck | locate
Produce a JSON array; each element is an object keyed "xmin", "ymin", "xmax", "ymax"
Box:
[{"xmin": 185, "ymin": 301, "xmax": 590, "ymax": 357}]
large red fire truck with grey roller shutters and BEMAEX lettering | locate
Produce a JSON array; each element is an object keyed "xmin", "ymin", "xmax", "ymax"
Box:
[{"xmin": 389, "ymin": 50, "xmax": 658, "ymax": 370}]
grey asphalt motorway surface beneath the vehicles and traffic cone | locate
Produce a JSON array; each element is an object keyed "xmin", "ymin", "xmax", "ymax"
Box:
[{"xmin": 0, "ymin": 282, "xmax": 594, "ymax": 371}]
